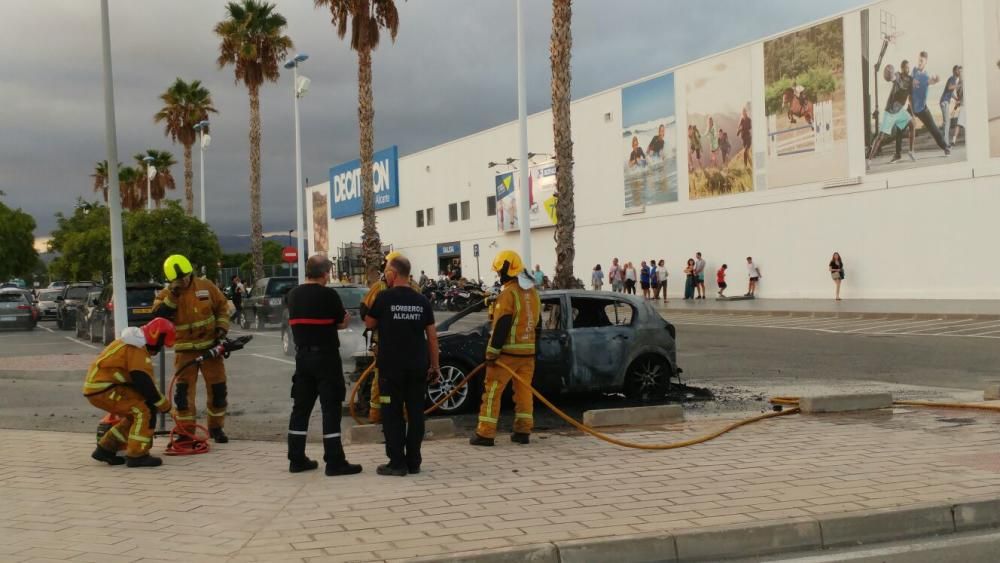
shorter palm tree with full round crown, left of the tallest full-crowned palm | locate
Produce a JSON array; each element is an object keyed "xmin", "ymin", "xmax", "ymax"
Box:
[{"xmin": 153, "ymin": 78, "xmax": 218, "ymax": 215}]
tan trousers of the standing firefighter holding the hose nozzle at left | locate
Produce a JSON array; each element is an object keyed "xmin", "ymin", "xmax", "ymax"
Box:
[{"xmin": 174, "ymin": 351, "xmax": 228, "ymax": 432}]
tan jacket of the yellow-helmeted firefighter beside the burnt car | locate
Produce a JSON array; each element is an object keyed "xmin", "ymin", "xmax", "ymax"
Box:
[{"xmin": 486, "ymin": 280, "xmax": 542, "ymax": 359}]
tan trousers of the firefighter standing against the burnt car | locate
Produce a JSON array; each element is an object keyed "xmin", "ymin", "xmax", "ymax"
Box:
[{"xmin": 476, "ymin": 354, "xmax": 535, "ymax": 438}]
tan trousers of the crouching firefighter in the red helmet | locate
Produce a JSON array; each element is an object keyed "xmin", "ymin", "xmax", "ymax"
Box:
[{"xmin": 87, "ymin": 385, "xmax": 156, "ymax": 457}]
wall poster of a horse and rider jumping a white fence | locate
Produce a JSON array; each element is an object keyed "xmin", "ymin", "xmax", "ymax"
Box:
[{"xmin": 764, "ymin": 18, "xmax": 848, "ymax": 187}]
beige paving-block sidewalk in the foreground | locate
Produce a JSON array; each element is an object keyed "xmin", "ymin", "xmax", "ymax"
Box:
[{"xmin": 0, "ymin": 408, "xmax": 1000, "ymax": 562}]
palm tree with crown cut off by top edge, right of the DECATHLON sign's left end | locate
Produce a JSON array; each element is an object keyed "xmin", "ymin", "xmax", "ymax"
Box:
[{"xmin": 315, "ymin": 0, "xmax": 399, "ymax": 283}]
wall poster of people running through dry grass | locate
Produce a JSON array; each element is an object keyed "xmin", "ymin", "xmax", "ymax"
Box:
[{"xmin": 678, "ymin": 49, "xmax": 754, "ymax": 199}]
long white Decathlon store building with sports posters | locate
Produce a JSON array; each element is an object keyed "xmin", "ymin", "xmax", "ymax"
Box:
[{"xmin": 306, "ymin": 0, "xmax": 1000, "ymax": 299}]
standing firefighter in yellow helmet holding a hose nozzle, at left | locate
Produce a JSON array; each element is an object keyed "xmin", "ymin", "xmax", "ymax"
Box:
[{"xmin": 153, "ymin": 254, "xmax": 229, "ymax": 444}]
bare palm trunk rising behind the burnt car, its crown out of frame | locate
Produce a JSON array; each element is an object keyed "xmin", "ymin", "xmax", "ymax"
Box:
[{"xmin": 550, "ymin": 0, "xmax": 576, "ymax": 288}]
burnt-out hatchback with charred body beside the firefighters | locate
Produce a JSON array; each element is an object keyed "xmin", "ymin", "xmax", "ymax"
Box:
[{"xmin": 416, "ymin": 290, "xmax": 682, "ymax": 414}]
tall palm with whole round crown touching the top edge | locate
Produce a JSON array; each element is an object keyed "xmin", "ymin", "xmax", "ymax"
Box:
[{"xmin": 215, "ymin": 0, "xmax": 294, "ymax": 279}]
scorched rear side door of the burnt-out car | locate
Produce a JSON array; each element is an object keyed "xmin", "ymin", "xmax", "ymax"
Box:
[{"xmin": 569, "ymin": 296, "xmax": 633, "ymax": 391}]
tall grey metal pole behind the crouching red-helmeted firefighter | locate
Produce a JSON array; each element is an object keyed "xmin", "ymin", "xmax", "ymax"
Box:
[{"xmin": 101, "ymin": 0, "xmax": 128, "ymax": 334}]
